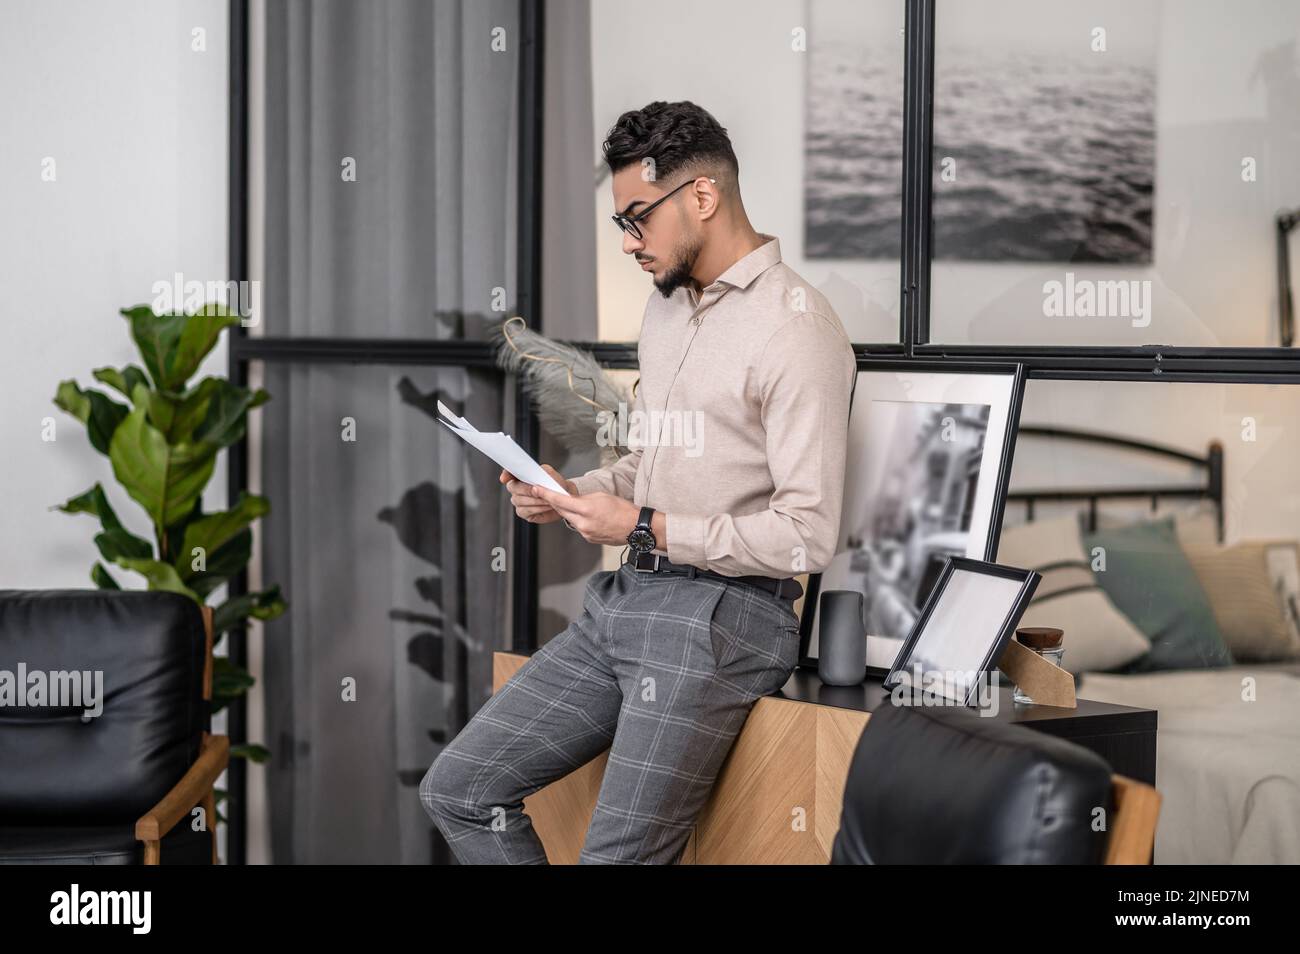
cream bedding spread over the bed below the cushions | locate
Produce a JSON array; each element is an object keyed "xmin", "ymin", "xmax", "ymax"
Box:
[{"xmin": 1079, "ymin": 663, "xmax": 1300, "ymax": 864}]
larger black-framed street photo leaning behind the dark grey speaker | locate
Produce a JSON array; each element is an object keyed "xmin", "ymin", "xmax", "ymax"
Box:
[{"xmin": 800, "ymin": 359, "xmax": 1024, "ymax": 672}]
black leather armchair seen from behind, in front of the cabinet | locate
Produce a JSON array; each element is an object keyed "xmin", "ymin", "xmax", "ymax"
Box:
[{"xmin": 831, "ymin": 704, "xmax": 1160, "ymax": 864}]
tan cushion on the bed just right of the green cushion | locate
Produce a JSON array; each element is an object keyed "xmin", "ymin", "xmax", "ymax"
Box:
[{"xmin": 1182, "ymin": 542, "xmax": 1300, "ymax": 663}]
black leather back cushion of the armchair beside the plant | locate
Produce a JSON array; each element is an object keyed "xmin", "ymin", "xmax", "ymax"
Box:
[{"xmin": 0, "ymin": 590, "xmax": 211, "ymax": 821}]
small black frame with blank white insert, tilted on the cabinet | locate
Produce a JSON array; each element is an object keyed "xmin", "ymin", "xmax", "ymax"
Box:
[{"xmin": 884, "ymin": 556, "xmax": 1043, "ymax": 704}]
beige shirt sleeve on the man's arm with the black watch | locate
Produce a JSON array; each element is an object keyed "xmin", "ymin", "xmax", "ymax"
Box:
[{"xmin": 666, "ymin": 312, "xmax": 857, "ymax": 577}]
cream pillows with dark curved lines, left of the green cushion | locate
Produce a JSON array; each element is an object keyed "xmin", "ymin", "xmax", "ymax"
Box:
[{"xmin": 997, "ymin": 513, "xmax": 1151, "ymax": 672}]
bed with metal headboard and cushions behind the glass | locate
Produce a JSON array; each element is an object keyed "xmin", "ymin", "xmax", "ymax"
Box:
[{"xmin": 997, "ymin": 425, "xmax": 1300, "ymax": 864}]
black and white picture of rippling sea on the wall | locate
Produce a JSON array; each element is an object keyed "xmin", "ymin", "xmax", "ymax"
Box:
[{"xmin": 803, "ymin": 0, "xmax": 1173, "ymax": 265}]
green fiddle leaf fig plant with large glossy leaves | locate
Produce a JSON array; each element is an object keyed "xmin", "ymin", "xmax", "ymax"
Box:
[{"xmin": 55, "ymin": 304, "xmax": 286, "ymax": 762}]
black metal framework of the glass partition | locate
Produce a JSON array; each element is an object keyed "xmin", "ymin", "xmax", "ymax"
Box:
[{"xmin": 220, "ymin": 0, "xmax": 1300, "ymax": 864}]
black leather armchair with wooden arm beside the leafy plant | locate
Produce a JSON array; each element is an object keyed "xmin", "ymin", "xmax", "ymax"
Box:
[{"xmin": 0, "ymin": 590, "xmax": 230, "ymax": 864}]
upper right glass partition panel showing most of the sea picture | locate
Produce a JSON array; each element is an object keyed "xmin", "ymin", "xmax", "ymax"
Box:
[{"xmin": 930, "ymin": 0, "xmax": 1300, "ymax": 347}]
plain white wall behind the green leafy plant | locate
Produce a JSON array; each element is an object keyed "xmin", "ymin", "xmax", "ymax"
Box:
[{"xmin": 0, "ymin": 0, "xmax": 228, "ymax": 587}]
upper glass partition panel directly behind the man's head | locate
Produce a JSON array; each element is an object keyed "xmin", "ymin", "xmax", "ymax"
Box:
[{"xmin": 589, "ymin": 0, "xmax": 904, "ymax": 342}]
